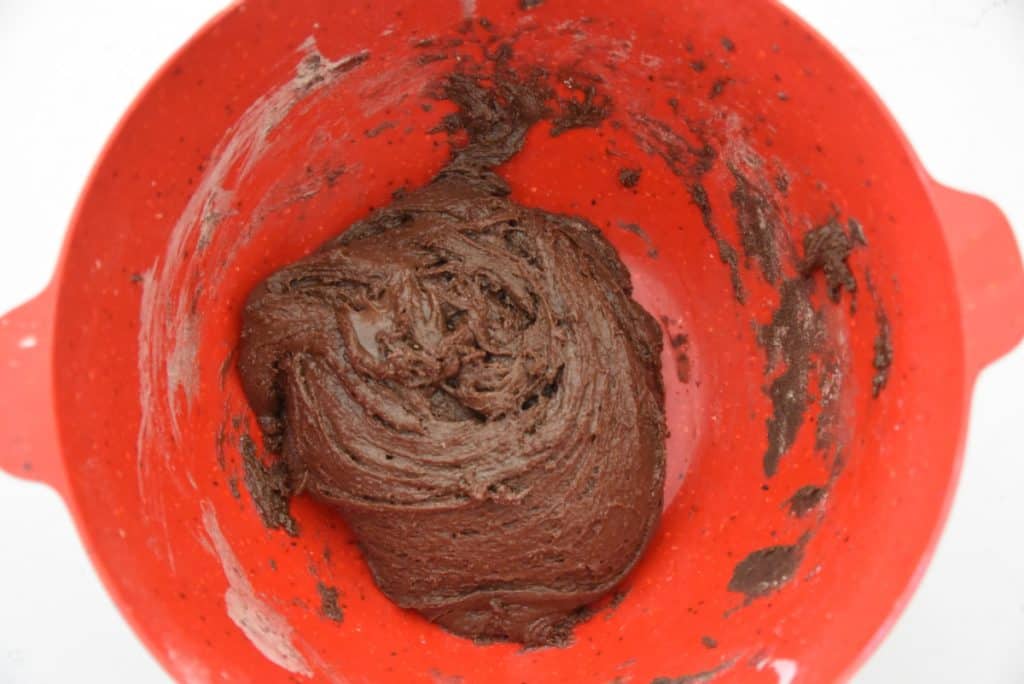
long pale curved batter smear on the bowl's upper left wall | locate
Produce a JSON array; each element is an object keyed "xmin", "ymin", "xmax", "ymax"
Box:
[{"xmin": 133, "ymin": 38, "xmax": 370, "ymax": 571}]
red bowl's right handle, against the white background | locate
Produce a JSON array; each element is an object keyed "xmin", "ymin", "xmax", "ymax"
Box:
[{"xmin": 932, "ymin": 181, "xmax": 1024, "ymax": 375}]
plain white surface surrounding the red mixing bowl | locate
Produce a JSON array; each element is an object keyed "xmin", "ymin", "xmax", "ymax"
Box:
[{"xmin": 0, "ymin": 0, "xmax": 1024, "ymax": 684}]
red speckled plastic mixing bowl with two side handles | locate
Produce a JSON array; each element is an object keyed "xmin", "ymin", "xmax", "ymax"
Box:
[{"xmin": 0, "ymin": 0, "xmax": 1024, "ymax": 683}]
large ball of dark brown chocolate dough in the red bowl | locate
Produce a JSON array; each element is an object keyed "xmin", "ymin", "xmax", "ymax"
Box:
[{"xmin": 239, "ymin": 177, "xmax": 666, "ymax": 646}]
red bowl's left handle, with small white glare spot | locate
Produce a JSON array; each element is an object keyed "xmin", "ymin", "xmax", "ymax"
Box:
[{"xmin": 0, "ymin": 286, "xmax": 66, "ymax": 494}]
